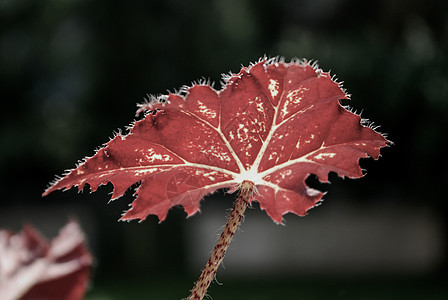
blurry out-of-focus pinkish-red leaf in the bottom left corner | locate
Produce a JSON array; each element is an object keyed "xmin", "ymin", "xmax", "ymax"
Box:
[{"xmin": 0, "ymin": 221, "xmax": 92, "ymax": 300}]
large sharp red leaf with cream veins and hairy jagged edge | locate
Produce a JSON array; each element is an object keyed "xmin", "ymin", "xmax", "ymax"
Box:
[{"xmin": 44, "ymin": 59, "xmax": 388, "ymax": 222}]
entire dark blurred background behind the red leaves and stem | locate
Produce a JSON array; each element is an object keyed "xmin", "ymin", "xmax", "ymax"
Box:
[{"xmin": 0, "ymin": 0, "xmax": 448, "ymax": 300}]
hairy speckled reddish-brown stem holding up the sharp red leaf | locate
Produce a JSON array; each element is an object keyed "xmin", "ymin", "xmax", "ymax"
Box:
[{"xmin": 188, "ymin": 181, "xmax": 255, "ymax": 300}]
